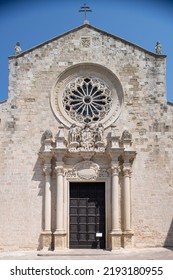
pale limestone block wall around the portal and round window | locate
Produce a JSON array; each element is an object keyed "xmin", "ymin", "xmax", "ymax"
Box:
[{"xmin": 0, "ymin": 24, "xmax": 173, "ymax": 249}]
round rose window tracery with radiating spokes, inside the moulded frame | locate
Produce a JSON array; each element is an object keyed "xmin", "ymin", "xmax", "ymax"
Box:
[{"xmin": 63, "ymin": 77, "xmax": 112, "ymax": 123}]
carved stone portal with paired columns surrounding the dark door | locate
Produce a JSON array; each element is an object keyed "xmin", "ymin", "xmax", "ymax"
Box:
[{"xmin": 40, "ymin": 126, "xmax": 136, "ymax": 250}]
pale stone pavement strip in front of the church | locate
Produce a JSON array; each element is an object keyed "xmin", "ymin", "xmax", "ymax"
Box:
[{"xmin": 0, "ymin": 248, "xmax": 173, "ymax": 260}]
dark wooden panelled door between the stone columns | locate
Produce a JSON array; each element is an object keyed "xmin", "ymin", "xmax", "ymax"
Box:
[{"xmin": 70, "ymin": 182, "xmax": 105, "ymax": 248}]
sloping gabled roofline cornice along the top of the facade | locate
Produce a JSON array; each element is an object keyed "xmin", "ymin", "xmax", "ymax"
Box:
[{"xmin": 9, "ymin": 23, "xmax": 166, "ymax": 59}]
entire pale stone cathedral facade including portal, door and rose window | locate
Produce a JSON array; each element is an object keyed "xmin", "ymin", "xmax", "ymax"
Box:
[{"xmin": 0, "ymin": 23, "xmax": 173, "ymax": 250}]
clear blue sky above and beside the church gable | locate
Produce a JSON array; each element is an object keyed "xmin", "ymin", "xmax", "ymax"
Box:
[{"xmin": 0, "ymin": 0, "xmax": 173, "ymax": 102}]
